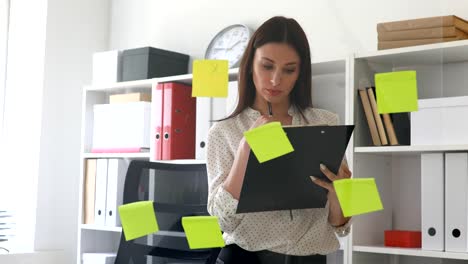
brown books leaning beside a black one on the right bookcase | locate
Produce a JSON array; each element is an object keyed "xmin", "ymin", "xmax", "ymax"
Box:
[{"xmin": 358, "ymin": 87, "xmax": 411, "ymax": 146}]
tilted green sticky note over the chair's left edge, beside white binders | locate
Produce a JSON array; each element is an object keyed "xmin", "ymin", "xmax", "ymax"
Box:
[{"xmin": 119, "ymin": 201, "xmax": 159, "ymax": 241}]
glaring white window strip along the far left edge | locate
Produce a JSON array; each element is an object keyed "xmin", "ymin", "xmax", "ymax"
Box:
[{"xmin": 0, "ymin": 0, "xmax": 47, "ymax": 251}]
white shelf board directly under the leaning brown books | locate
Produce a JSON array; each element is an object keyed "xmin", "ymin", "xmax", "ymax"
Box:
[{"xmin": 354, "ymin": 145, "xmax": 468, "ymax": 154}]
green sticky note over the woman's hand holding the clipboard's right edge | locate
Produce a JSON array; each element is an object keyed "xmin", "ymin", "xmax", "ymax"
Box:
[{"xmin": 333, "ymin": 178, "xmax": 383, "ymax": 217}]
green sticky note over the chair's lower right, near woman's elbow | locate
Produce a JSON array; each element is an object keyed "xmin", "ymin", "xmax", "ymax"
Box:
[{"xmin": 182, "ymin": 216, "xmax": 224, "ymax": 249}]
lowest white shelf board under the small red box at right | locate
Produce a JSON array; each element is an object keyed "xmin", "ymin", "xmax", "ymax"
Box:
[{"xmin": 353, "ymin": 246, "xmax": 468, "ymax": 259}]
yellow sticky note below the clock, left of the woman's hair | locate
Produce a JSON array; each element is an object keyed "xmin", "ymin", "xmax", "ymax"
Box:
[{"xmin": 192, "ymin": 60, "xmax": 229, "ymax": 97}]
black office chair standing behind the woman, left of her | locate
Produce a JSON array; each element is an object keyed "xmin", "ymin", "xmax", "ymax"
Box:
[{"xmin": 115, "ymin": 160, "xmax": 219, "ymax": 264}]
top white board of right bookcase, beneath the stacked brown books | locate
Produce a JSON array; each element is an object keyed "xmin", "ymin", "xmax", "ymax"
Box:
[{"xmin": 355, "ymin": 40, "xmax": 468, "ymax": 67}]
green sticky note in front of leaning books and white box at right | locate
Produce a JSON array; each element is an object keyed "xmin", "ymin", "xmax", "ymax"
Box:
[{"xmin": 375, "ymin": 71, "xmax": 418, "ymax": 114}]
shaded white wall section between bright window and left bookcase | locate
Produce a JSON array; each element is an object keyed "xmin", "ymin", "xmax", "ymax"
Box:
[{"xmin": 35, "ymin": 0, "xmax": 110, "ymax": 263}]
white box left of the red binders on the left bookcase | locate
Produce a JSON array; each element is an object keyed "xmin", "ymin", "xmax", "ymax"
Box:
[{"xmin": 91, "ymin": 102, "xmax": 151, "ymax": 153}]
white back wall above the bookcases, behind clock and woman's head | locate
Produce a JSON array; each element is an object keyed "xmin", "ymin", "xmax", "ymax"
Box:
[{"xmin": 110, "ymin": 0, "xmax": 468, "ymax": 60}]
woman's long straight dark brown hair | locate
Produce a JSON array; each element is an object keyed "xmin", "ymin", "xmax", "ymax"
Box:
[{"xmin": 225, "ymin": 16, "xmax": 312, "ymax": 119}]
